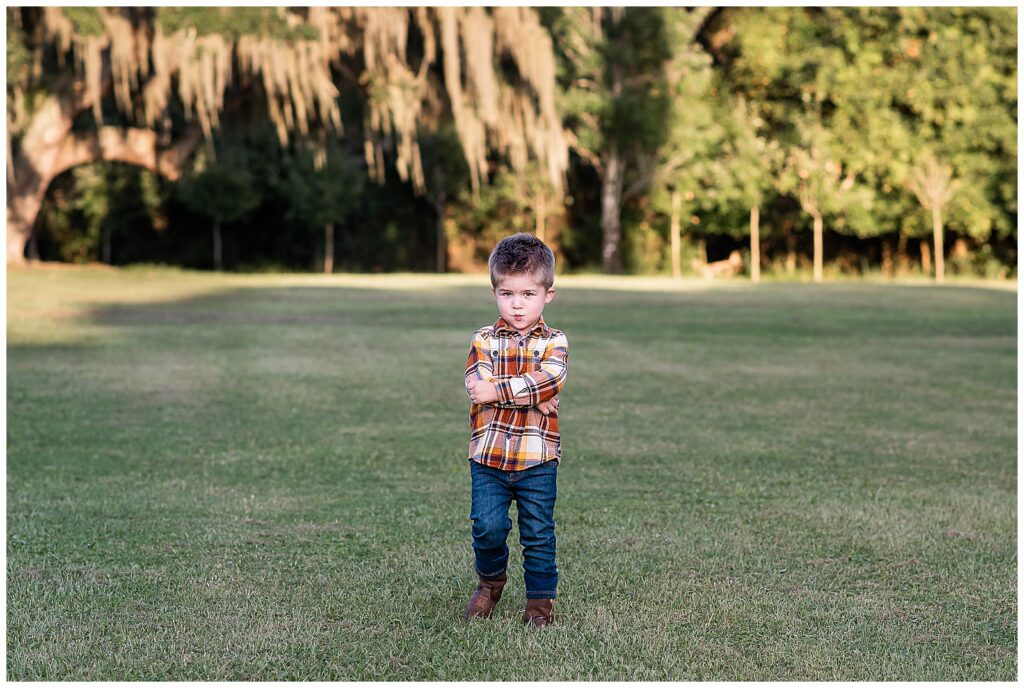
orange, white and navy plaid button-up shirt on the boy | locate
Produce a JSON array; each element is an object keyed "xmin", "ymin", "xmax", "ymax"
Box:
[{"xmin": 466, "ymin": 316, "xmax": 569, "ymax": 471}]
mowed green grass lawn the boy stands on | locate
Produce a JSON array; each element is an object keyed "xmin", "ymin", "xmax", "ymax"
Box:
[{"xmin": 6, "ymin": 268, "xmax": 1017, "ymax": 681}]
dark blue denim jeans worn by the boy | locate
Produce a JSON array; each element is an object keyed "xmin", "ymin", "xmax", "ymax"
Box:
[{"xmin": 469, "ymin": 460, "xmax": 558, "ymax": 600}]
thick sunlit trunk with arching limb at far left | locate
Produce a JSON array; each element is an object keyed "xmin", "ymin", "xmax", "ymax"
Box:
[{"xmin": 7, "ymin": 82, "xmax": 201, "ymax": 263}]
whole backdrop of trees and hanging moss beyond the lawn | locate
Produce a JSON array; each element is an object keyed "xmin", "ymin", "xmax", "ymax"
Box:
[{"xmin": 6, "ymin": 7, "xmax": 1017, "ymax": 276}]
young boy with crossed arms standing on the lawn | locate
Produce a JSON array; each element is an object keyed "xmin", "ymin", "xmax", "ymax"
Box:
[{"xmin": 465, "ymin": 233, "xmax": 568, "ymax": 627}]
